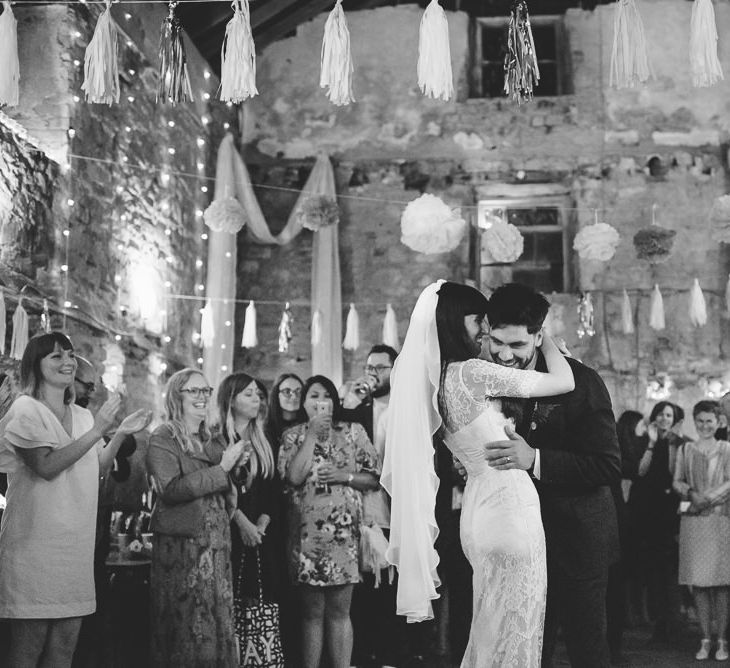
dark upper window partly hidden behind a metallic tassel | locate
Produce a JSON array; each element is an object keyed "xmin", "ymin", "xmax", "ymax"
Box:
[{"xmin": 470, "ymin": 16, "xmax": 572, "ymax": 97}]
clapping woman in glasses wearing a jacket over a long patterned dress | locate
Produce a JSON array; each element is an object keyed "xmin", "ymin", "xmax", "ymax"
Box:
[{"xmin": 147, "ymin": 369, "xmax": 245, "ymax": 668}]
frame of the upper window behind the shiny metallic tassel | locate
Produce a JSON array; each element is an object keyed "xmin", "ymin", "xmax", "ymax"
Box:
[{"xmin": 469, "ymin": 14, "xmax": 573, "ymax": 100}]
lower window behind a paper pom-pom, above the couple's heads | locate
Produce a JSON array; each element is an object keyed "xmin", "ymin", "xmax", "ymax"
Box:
[{"xmin": 477, "ymin": 190, "xmax": 571, "ymax": 293}]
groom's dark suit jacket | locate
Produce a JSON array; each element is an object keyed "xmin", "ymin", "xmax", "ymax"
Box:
[{"xmin": 518, "ymin": 355, "xmax": 621, "ymax": 579}]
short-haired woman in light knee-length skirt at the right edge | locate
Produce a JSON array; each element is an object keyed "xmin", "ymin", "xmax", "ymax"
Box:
[{"xmin": 674, "ymin": 401, "xmax": 730, "ymax": 661}]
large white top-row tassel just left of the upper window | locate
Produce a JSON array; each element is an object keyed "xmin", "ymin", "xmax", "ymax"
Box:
[{"xmin": 418, "ymin": 0, "xmax": 454, "ymax": 102}]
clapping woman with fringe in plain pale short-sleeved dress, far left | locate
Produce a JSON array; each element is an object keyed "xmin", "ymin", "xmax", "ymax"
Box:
[{"xmin": 0, "ymin": 332, "xmax": 151, "ymax": 668}]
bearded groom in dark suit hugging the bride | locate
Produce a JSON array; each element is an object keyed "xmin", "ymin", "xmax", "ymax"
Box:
[{"xmin": 485, "ymin": 283, "xmax": 621, "ymax": 668}]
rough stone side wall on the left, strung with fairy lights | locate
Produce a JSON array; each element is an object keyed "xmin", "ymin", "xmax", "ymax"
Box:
[{"xmin": 0, "ymin": 4, "xmax": 235, "ymax": 422}]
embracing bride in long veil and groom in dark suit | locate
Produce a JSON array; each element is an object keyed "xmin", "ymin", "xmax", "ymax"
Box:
[{"xmin": 381, "ymin": 281, "xmax": 621, "ymax": 668}]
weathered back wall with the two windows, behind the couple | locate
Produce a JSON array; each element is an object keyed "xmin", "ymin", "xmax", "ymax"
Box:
[{"xmin": 237, "ymin": 0, "xmax": 730, "ymax": 430}]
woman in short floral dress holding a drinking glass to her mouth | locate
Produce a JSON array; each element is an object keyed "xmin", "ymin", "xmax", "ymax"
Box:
[{"xmin": 279, "ymin": 376, "xmax": 380, "ymax": 668}]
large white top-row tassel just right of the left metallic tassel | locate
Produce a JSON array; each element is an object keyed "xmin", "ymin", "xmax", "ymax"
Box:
[{"xmin": 220, "ymin": 0, "xmax": 259, "ymax": 103}]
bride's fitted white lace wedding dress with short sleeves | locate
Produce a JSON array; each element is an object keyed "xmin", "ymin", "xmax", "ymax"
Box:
[{"xmin": 443, "ymin": 360, "xmax": 547, "ymax": 668}]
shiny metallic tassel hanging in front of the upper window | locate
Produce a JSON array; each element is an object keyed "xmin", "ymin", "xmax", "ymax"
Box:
[{"xmin": 504, "ymin": 0, "xmax": 540, "ymax": 104}]
